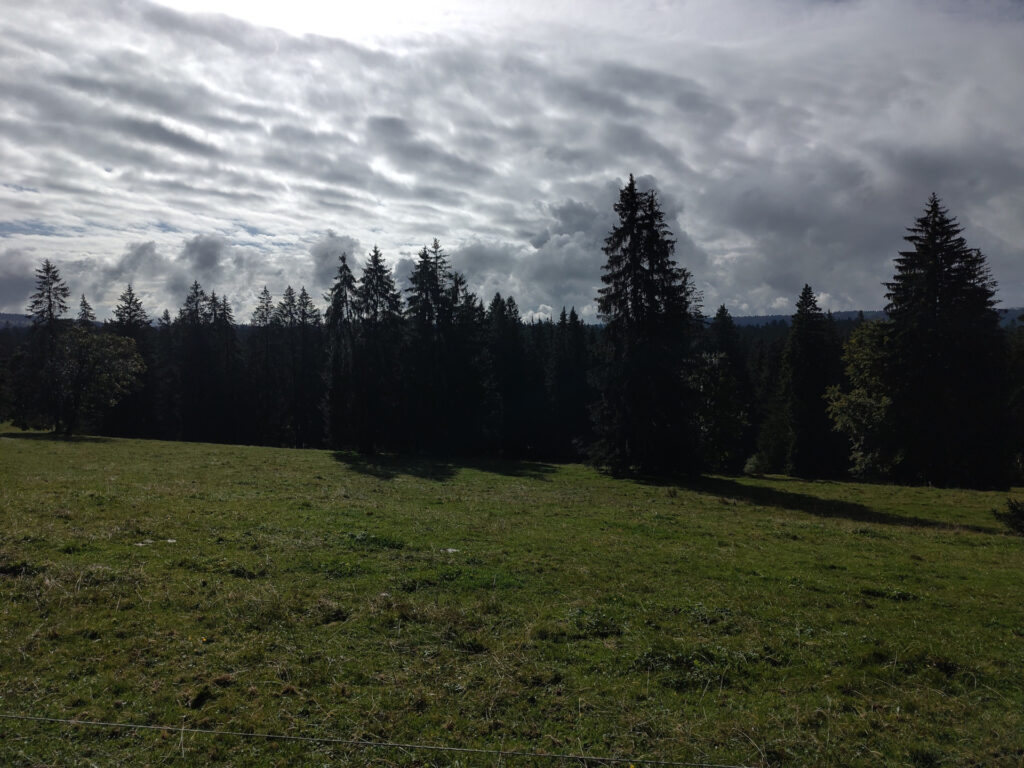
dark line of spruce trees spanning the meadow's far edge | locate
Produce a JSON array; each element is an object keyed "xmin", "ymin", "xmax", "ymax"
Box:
[{"xmin": 0, "ymin": 182, "xmax": 1024, "ymax": 487}]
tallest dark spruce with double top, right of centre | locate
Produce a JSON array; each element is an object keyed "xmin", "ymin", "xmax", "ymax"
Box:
[{"xmin": 592, "ymin": 175, "xmax": 699, "ymax": 472}]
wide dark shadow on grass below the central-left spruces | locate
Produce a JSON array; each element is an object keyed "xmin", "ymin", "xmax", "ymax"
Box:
[{"xmin": 332, "ymin": 451, "xmax": 556, "ymax": 482}]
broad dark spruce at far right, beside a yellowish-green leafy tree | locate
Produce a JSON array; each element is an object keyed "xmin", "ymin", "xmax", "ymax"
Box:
[{"xmin": 885, "ymin": 195, "xmax": 1009, "ymax": 486}]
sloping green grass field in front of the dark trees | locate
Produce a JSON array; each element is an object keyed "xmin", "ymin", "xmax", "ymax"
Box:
[{"xmin": 0, "ymin": 428, "xmax": 1024, "ymax": 766}]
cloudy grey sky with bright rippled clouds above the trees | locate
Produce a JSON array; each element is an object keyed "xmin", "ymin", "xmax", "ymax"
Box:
[{"xmin": 0, "ymin": 0, "xmax": 1024, "ymax": 322}]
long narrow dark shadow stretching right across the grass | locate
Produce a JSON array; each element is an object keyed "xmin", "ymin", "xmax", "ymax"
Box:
[{"xmin": 682, "ymin": 477, "xmax": 1000, "ymax": 534}]
